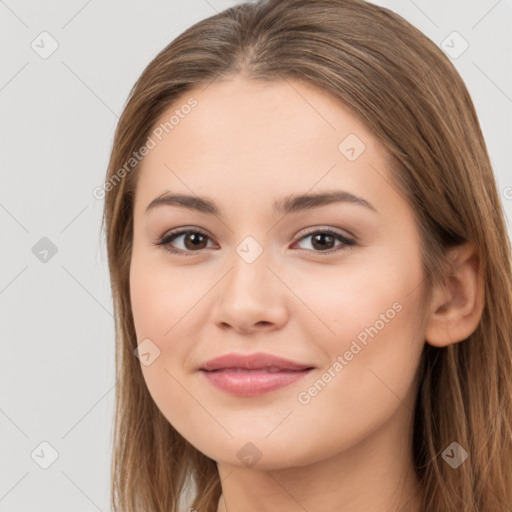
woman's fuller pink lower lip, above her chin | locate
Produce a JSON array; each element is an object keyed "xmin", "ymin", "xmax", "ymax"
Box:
[{"xmin": 201, "ymin": 368, "xmax": 312, "ymax": 396}]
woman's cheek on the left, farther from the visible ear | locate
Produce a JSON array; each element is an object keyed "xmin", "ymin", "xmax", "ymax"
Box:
[{"xmin": 130, "ymin": 251, "xmax": 214, "ymax": 412}]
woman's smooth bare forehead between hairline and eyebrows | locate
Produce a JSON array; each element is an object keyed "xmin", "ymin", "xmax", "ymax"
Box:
[{"xmin": 133, "ymin": 78, "xmax": 396, "ymax": 214}]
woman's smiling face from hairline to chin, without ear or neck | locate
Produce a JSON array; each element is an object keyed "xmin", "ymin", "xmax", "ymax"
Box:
[{"xmin": 130, "ymin": 78, "xmax": 425, "ymax": 469}]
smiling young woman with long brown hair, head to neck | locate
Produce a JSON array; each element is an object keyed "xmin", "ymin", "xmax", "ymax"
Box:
[{"xmin": 104, "ymin": 0, "xmax": 512, "ymax": 512}]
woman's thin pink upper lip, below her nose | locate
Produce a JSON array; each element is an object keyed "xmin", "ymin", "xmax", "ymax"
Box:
[{"xmin": 199, "ymin": 352, "xmax": 313, "ymax": 371}]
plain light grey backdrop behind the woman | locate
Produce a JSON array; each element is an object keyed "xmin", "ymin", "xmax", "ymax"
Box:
[{"xmin": 0, "ymin": 0, "xmax": 512, "ymax": 512}]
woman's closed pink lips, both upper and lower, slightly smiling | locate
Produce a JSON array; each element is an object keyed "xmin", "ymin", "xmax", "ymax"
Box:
[{"xmin": 199, "ymin": 353, "xmax": 313, "ymax": 396}]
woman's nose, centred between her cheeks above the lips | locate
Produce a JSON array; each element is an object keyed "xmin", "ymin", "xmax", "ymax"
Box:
[{"xmin": 213, "ymin": 255, "xmax": 288, "ymax": 334}]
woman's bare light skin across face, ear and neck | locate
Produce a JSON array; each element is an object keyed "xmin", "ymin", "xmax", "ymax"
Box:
[{"xmin": 130, "ymin": 77, "xmax": 483, "ymax": 512}]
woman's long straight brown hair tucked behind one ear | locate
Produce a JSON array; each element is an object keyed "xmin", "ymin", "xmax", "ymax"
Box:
[{"xmin": 102, "ymin": 0, "xmax": 512, "ymax": 512}]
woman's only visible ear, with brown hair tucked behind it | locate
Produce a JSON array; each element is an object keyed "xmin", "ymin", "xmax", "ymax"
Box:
[{"xmin": 425, "ymin": 243, "xmax": 485, "ymax": 347}]
